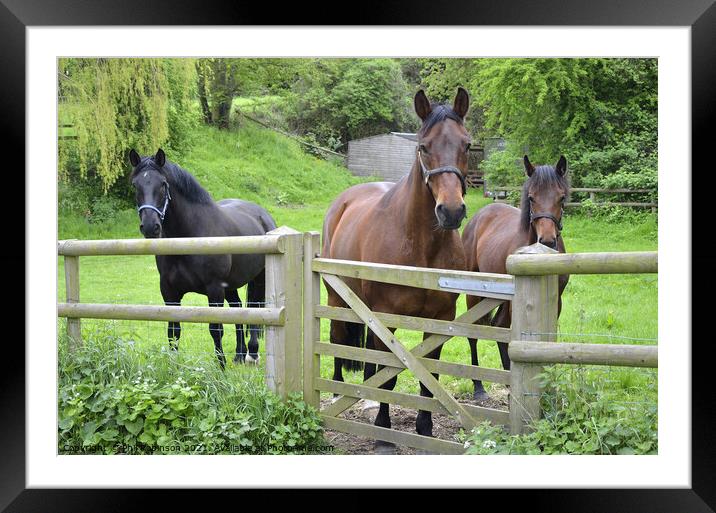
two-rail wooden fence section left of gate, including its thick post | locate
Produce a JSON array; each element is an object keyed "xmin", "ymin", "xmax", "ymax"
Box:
[{"xmin": 57, "ymin": 226, "xmax": 304, "ymax": 398}]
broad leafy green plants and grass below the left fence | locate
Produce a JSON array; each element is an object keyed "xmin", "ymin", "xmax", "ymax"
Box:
[{"xmin": 58, "ymin": 335, "xmax": 326, "ymax": 454}]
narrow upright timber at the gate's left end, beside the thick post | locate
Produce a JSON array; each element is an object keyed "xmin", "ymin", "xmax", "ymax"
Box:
[{"xmin": 303, "ymin": 232, "xmax": 321, "ymax": 409}]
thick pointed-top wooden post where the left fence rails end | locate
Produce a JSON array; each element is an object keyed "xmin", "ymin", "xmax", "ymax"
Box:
[{"xmin": 266, "ymin": 226, "xmax": 303, "ymax": 399}]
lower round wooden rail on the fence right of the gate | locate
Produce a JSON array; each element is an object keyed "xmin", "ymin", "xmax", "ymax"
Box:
[{"xmin": 508, "ymin": 340, "xmax": 659, "ymax": 368}]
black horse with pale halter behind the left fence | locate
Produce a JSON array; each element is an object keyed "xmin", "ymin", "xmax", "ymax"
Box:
[{"xmin": 129, "ymin": 149, "xmax": 276, "ymax": 368}]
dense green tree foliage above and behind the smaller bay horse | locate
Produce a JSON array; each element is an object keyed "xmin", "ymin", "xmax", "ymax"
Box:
[{"xmin": 424, "ymin": 59, "xmax": 657, "ymax": 186}]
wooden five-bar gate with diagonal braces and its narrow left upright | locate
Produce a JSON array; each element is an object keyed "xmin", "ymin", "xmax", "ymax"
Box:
[{"xmin": 303, "ymin": 232, "xmax": 515, "ymax": 454}]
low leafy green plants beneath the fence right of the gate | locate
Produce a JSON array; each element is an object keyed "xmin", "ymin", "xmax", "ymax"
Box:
[{"xmin": 464, "ymin": 366, "xmax": 658, "ymax": 454}]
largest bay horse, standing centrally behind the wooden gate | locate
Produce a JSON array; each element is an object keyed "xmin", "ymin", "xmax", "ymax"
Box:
[{"xmin": 321, "ymin": 88, "xmax": 470, "ymax": 452}]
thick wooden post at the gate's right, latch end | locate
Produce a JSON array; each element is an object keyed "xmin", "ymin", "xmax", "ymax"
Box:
[{"xmin": 510, "ymin": 243, "xmax": 558, "ymax": 434}]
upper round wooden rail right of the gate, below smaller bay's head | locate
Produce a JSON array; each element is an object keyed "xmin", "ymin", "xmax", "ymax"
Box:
[{"xmin": 507, "ymin": 251, "xmax": 658, "ymax": 276}]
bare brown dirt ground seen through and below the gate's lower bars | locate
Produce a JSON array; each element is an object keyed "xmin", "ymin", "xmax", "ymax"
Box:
[{"xmin": 321, "ymin": 386, "xmax": 507, "ymax": 454}]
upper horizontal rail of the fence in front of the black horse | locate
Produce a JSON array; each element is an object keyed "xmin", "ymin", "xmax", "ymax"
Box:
[{"xmin": 57, "ymin": 235, "xmax": 284, "ymax": 256}]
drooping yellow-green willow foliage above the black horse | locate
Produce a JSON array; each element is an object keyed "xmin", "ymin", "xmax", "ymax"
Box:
[{"xmin": 58, "ymin": 58, "xmax": 196, "ymax": 193}]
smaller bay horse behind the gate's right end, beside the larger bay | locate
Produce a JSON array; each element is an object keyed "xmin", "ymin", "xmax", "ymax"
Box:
[{"xmin": 462, "ymin": 155, "xmax": 569, "ymax": 401}]
